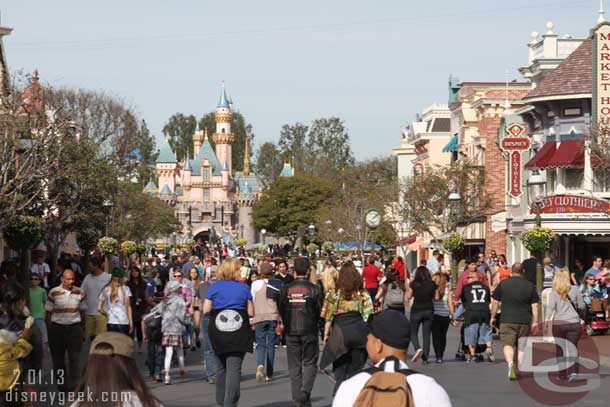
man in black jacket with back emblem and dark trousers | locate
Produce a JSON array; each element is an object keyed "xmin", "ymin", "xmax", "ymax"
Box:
[{"xmin": 279, "ymin": 257, "xmax": 322, "ymax": 407}]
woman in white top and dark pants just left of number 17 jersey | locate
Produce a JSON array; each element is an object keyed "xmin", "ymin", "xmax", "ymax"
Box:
[{"xmin": 432, "ymin": 273, "xmax": 454, "ymax": 363}]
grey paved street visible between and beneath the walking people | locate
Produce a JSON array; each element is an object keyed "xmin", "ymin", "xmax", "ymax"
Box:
[{"xmin": 144, "ymin": 328, "xmax": 610, "ymax": 407}]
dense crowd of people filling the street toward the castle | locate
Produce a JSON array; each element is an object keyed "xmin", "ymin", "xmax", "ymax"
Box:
[{"xmin": 0, "ymin": 250, "xmax": 610, "ymax": 406}]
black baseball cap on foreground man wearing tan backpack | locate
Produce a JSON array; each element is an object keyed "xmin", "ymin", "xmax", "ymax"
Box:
[{"xmin": 368, "ymin": 310, "xmax": 411, "ymax": 349}]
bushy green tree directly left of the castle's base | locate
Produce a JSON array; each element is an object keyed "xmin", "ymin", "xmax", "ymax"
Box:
[{"xmin": 112, "ymin": 183, "xmax": 180, "ymax": 242}]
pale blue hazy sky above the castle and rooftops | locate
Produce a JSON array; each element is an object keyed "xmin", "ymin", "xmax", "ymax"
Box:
[{"xmin": 0, "ymin": 0, "xmax": 610, "ymax": 160}]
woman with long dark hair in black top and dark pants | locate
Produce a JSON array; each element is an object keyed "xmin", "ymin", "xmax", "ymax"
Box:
[{"xmin": 407, "ymin": 266, "xmax": 437, "ymax": 364}]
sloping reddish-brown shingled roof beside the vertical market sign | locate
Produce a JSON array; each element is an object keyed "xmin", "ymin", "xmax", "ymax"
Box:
[{"xmin": 525, "ymin": 38, "xmax": 593, "ymax": 100}]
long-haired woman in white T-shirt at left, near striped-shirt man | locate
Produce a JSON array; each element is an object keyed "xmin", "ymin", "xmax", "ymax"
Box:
[{"xmin": 98, "ymin": 267, "xmax": 133, "ymax": 335}]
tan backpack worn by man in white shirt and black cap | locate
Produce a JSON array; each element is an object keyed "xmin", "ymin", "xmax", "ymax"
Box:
[{"xmin": 353, "ymin": 357, "xmax": 417, "ymax": 407}]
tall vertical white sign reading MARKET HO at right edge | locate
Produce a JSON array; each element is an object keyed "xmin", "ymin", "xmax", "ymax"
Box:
[{"xmin": 593, "ymin": 22, "xmax": 610, "ymax": 130}]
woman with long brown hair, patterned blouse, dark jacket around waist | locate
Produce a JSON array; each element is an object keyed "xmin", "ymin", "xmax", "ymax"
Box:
[{"xmin": 320, "ymin": 262, "xmax": 373, "ymax": 392}]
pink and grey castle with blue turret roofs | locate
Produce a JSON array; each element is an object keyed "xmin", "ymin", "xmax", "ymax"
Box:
[{"xmin": 144, "ymin": 83, "xmax": 262, "ymax": 244}]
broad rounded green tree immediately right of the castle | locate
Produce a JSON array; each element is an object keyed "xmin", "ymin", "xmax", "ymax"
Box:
[{"xmin": 252, "ymin": 174, "xmax": 334, "ymax": 239}]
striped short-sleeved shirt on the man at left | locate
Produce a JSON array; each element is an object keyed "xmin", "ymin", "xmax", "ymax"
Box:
[{"xmin": 45, "ymin": 285, "xmax": 87, "ymax": 325}]
